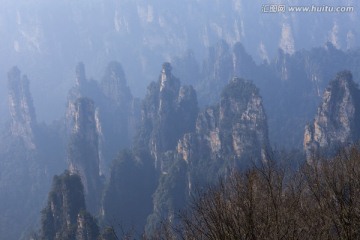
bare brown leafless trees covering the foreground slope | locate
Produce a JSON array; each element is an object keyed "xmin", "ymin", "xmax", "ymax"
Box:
[{"xmin": 157, "ymin": 147, "xmax": 360, "ymax": 239}]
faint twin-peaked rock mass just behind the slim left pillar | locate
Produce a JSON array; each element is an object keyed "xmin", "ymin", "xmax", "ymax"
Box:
[{"xmin": 66, "ymin": 61, "xmax": 140, "ymax": 175}]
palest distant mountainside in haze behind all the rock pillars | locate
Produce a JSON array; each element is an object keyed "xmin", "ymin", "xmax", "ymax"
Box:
[{"xmin": 0, "ymin": 0, "xmax": 359, "ymax": 124}]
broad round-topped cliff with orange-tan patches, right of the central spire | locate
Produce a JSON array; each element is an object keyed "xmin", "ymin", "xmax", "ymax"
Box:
[{"xmin": 146, "ymin": 78, "xmax": 270, "ymax": 234}]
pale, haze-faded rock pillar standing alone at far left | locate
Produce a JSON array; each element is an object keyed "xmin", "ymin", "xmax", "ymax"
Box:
[{"xmin": 8, "ymin": 67, "xmax": 36, "ymax": 149}]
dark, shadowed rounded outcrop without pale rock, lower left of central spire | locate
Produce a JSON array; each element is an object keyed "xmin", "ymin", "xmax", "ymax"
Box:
[{"xmin": 101, "ymin": 150, "xmax": 158, "ymax": 238}]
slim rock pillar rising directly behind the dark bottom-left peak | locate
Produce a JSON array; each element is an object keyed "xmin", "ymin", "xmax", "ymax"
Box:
[{"xmin": 68, "ymin": 98, "xmax": 101, "ymax": 212}]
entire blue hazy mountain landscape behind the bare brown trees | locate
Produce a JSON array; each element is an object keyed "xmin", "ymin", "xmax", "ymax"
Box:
[{"xmin": 0, "ymin": 0, "xmax": 360, "ymax": 240}]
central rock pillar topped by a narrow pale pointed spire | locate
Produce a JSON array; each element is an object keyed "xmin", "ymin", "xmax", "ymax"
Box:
[{"xmin": 137, "ymin": 63, "xmax": 198, "ymax": 170}]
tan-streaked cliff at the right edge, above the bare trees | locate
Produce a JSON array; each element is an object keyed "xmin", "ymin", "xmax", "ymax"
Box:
[{"xmin": 304, "ymin": 71, "xmax": 360, "ymax": 157}]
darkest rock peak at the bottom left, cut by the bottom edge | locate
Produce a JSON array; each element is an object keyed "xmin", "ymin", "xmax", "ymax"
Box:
[{"xmin": 41, "ymin": 172, "xmax": 99, "ymax": 240}]
